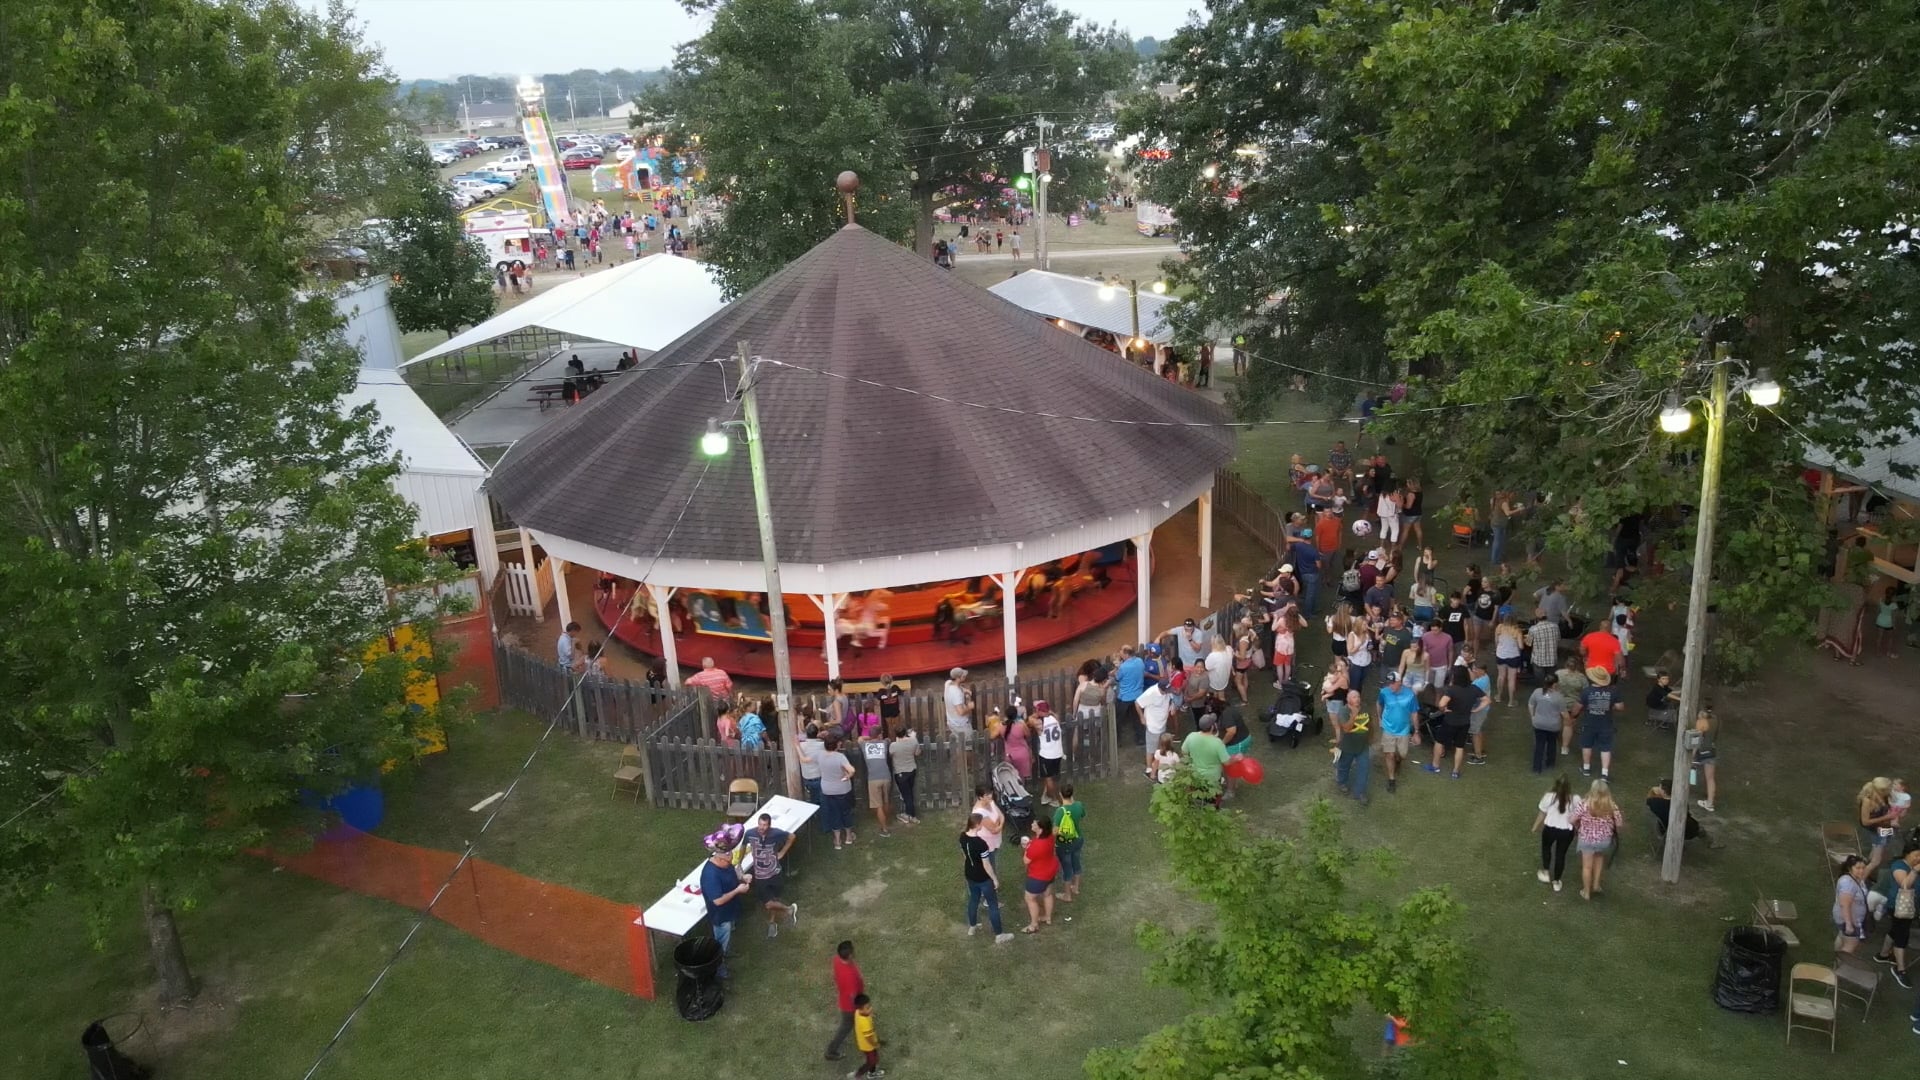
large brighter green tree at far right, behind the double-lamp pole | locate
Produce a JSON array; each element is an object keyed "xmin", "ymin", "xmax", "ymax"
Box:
[{"xmin": 1290, "ymin": 0, "xmax": 1920, "ymax": 673}]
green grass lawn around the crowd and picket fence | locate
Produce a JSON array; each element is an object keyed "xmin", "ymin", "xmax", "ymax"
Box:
[{"xmin": 11, "ymin": 372, "xmax": 1914, "ymax": 1080}]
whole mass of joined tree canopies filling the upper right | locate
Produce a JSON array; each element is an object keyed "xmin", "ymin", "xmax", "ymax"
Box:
[{"xmin": 1137, "ymin": 0, "xmax": 1920, "ymax": 669}]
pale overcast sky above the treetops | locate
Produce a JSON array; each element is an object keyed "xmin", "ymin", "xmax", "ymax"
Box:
[{"xmin": 330, "ymin": 0, "xmax": 1200, "ymax": 79}]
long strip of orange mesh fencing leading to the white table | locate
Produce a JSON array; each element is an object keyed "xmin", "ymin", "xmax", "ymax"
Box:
[{"xmin": 265, "ymin": 832, "xmax": 653, "ymax": 999}]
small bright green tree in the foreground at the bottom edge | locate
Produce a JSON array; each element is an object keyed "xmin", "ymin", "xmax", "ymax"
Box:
[{"xmin": 1087, "ymin": 769, "xmax": 1519, "ymax": 1080}]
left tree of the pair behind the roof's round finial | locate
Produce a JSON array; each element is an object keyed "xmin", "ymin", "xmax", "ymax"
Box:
[{"xmin": 634, "ymin": 0, "xmax": 912, "ymax": 296}]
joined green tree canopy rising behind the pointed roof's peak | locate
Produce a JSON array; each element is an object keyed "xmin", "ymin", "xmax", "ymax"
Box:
[{"xmin": 636, "ymin": 0, "xmax": 1137, "ymax": 292}]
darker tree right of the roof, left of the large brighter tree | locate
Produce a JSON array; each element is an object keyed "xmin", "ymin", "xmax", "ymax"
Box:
[{"xmin": 1121, "ymin": 0, "xmax": 1398, "ymax": 419}]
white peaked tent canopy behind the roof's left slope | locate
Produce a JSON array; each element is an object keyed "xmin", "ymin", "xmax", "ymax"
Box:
[{"xmin": 407, "ymin": 256, "xmax": 724, "ymax": 363}]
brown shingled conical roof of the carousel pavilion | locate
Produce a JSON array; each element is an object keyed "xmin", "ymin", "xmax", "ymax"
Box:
[{"xmin": 490, "ymin": 227, "xmax": 1233, "ymax": 563}]
